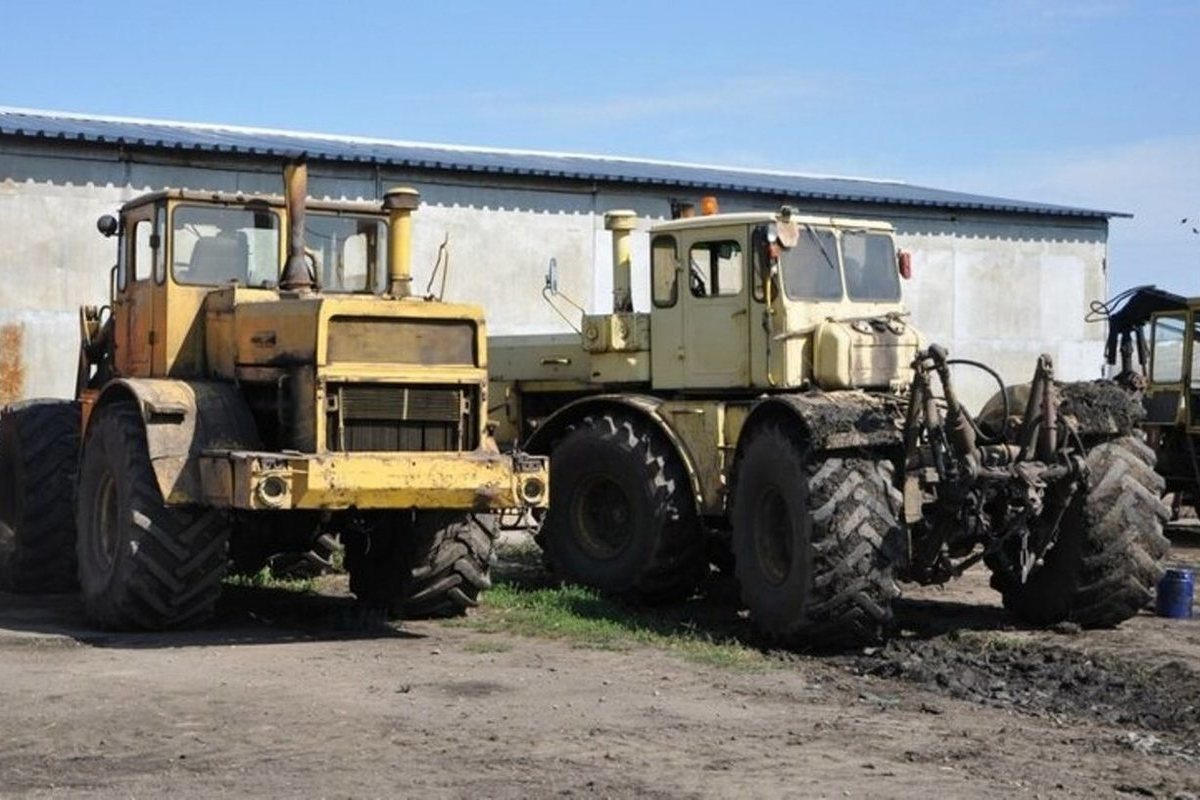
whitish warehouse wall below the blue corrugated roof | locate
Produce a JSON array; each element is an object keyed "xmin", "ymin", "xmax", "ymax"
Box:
[{"xmin": 0, "ymin": 143, "xmax": 1106, "ymax": 404}]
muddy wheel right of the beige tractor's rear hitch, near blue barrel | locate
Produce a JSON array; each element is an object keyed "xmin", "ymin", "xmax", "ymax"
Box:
[{"xmin": 991, "ymin": 437, "xmax": 1170, "ymax": 627}]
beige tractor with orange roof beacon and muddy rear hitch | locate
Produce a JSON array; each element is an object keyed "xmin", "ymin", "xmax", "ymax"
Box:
[{"xmin": 491, "ymin": 207, "xmax": 1166, "ymax": 644}]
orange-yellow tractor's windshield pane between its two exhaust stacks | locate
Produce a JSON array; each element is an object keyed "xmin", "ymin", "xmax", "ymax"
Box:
[{"xmin": 304, "ymin": 211, "xmax": 386, "ymax": 291}]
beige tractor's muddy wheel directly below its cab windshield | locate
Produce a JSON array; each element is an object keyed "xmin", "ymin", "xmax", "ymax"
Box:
[{"xmin": 733, "ymin": 423, "xmax": 904, "ymax": 646}]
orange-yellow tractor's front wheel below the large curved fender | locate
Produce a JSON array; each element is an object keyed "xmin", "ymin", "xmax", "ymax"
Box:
[{"xmin": 76, "ymin": 403, "xmax": 229, "ymax": 630}]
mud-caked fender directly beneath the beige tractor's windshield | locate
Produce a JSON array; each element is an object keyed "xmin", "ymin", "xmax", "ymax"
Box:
[{"xmin": 738, "ymin": 391, "xmax": 905, "ymax": 453}]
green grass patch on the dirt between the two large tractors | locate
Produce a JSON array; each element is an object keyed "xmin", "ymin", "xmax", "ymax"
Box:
[{"xmin": 461, "ymin": 579, "xmax": 770, "ymax": 669}]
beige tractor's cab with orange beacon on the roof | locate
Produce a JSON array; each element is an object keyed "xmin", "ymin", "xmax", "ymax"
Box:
[{"xmin": 650, "ymin": 207, "xmax": 918, "ymax": 389}]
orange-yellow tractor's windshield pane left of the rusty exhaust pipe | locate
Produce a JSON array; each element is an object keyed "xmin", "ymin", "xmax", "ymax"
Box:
[{"xmin": 172, "ymin": 205, "xmax": 280, "ymax": 287}]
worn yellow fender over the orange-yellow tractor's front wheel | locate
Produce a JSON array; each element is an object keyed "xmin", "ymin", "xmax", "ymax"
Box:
[{"xmin": 85, "ymin": 378, "xmax": 262, "ymax": 505}]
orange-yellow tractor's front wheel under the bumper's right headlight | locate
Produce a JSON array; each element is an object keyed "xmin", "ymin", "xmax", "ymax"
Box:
[{"xmin": 344, "ymin": 511, "xmax": 496, "ymax": 619}]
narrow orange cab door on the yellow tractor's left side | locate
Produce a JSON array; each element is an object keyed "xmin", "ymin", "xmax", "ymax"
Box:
[{"xmin": 113, "ymin": 206, "xmax": 162, "ymax": 378}]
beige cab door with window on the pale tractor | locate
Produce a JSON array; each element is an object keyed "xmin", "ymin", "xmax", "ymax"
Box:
[{"xmin": 679, "ymin": 227, "xmax": 750, "ymax": 389}]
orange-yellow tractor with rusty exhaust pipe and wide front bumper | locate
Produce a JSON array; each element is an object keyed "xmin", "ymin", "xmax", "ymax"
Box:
[{"xmin": 0, "ymin": 160, "xmax": 548, "ymax": 628}]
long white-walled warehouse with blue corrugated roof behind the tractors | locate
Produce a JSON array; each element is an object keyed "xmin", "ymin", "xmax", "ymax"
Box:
[{"xmin": 0, "ymin": 108, "xmax": 1123, "ymax": 404}]
